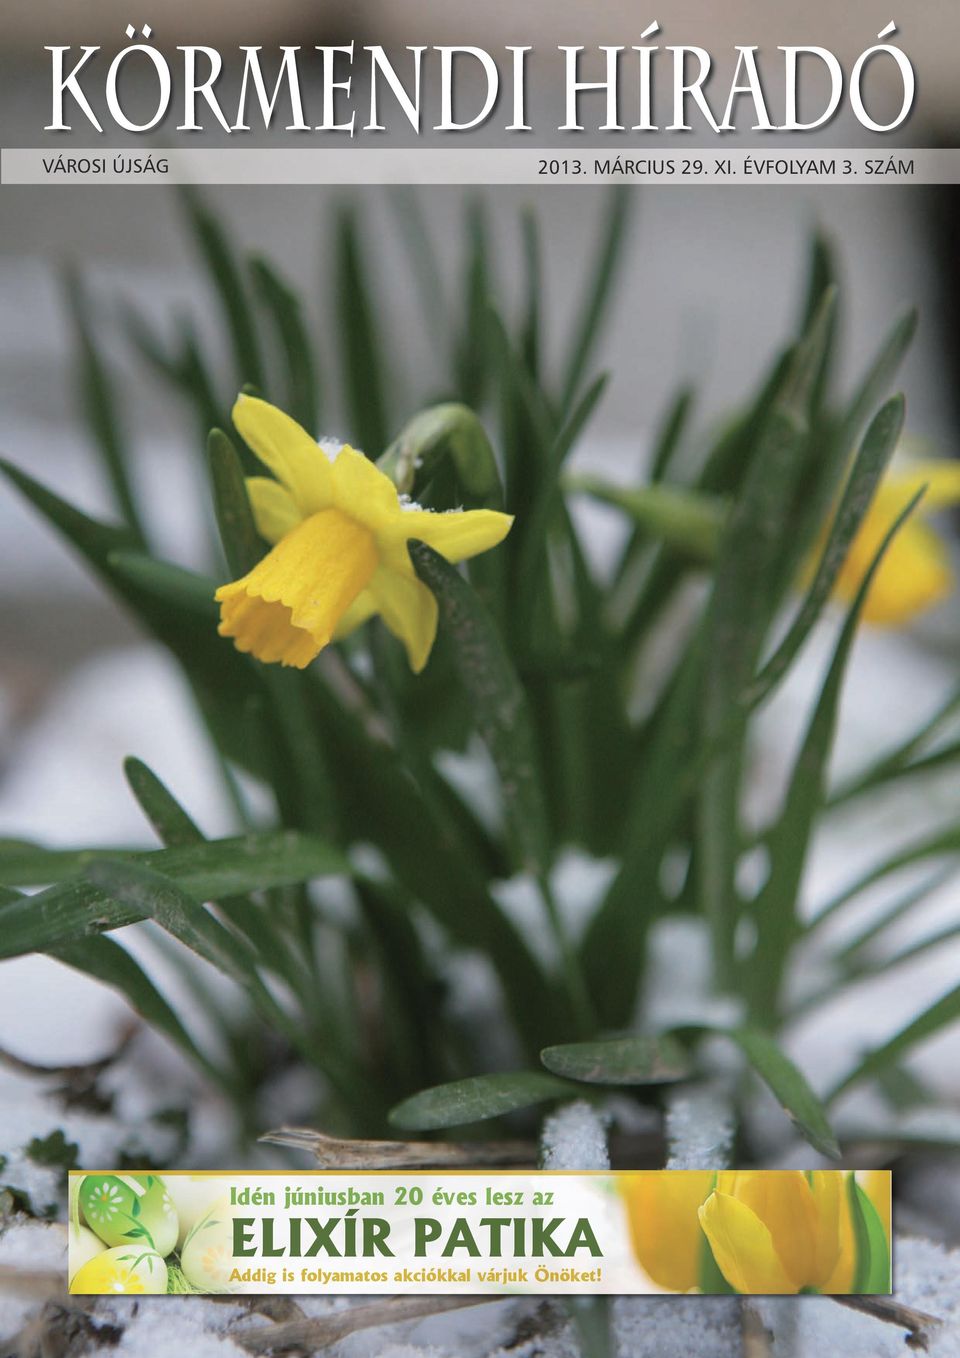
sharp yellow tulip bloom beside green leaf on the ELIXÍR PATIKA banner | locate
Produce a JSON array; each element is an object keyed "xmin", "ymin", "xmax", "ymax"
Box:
[{"xmin": 699, "ymin": 1171, "xmax": 845, "ymax": 1294}]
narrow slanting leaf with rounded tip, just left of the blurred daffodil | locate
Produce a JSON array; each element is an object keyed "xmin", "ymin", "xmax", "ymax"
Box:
[{"xmin": 743, "ymin": 397, "xmax": 904, "ymax": 706}]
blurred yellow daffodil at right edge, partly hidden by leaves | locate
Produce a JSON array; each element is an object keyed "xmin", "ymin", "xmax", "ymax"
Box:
[{"xmin": 835, "ymin": 460, "xmax": 960, "ymax": 627}]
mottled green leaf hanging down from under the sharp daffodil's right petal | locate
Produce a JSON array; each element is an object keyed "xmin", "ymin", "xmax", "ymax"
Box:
[{"xmin": 410, "ymin": 543, "xmax": 550, "ymax": 876}]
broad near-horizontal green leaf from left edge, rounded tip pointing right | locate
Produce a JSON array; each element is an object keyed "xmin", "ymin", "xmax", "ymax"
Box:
[{"xmin": 0, "ymin": 830, "xmax": 350, "ymax": 957}]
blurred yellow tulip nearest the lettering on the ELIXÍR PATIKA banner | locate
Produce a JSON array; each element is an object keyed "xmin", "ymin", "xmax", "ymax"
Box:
[{"xmin": 623, "ymin": 1169, "xmax": 714, "ymax": 1291}]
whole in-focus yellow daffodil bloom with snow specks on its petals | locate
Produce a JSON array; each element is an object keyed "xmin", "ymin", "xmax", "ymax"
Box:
[{"xmin": 216, "ymin": 395, "xmax": 513, "ymax": 674}]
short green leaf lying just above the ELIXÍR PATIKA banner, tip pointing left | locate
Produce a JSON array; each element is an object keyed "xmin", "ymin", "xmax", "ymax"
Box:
[{"xmin": 390, "ymin": 1070, "xmax": 583, "ymax": 1131}]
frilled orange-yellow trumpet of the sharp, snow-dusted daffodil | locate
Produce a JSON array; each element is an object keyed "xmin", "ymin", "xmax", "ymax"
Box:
[{"xmin": 216, "ymin": 509, "xmax": 377, "ymax": 669}]
